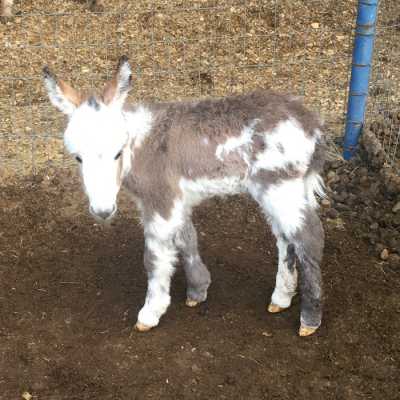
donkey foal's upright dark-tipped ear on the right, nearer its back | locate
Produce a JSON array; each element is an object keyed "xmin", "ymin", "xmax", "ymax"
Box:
[{"xmin": 102, "ymin": 56, "xmax": 132, "ymax": 107}]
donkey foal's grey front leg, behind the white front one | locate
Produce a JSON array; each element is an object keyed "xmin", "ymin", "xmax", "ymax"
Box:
[{"xmin": 175, "ymin": 220, "xmax": 211, "ymax": 307}]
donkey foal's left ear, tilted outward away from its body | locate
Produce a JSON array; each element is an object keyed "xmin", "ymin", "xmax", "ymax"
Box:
[{"xmin": 43, "ymin": 67, "xmax": 82, "ymax": 115}]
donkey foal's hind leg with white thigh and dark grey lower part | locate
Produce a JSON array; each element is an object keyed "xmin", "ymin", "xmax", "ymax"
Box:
[{"xmin": 250, "ymin": 178, "xmax": 324, "ymax": 336}]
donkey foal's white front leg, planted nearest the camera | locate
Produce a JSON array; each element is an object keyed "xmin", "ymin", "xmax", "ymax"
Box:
[{"xmin": 135, "ymin": 235, "xmax": 177, "ymax": 332}]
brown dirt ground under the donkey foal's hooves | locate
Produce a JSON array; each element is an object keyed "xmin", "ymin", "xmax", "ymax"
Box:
[{"xmin": 0, "ymin": 167, "xmax": 400, "ymax": 400}]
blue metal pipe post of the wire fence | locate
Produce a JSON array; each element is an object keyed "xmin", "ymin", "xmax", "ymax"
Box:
[{"xmin": 343, "ymin": 0, "xmax": 379, "ymax": 160}]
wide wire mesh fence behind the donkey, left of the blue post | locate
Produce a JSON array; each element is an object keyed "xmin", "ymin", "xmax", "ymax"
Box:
[{"xmin": 0, "ymin": 0, "xmax": 356, "ymax": 174}]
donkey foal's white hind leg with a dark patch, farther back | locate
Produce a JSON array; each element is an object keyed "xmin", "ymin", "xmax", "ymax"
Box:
[{"xmin": 268, "ymin": 236, "xmax": 297, "ymax": 313}]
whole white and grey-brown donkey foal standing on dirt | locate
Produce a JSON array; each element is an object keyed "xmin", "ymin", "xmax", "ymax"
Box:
[{"xmin": 44, "ymin": 57, "xmax": 324, "ymax": 336}]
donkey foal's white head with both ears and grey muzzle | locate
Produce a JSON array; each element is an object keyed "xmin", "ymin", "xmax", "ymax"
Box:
[{"xmin": 43, "ymin": 56, "xmax": 132, "ymax": 220}]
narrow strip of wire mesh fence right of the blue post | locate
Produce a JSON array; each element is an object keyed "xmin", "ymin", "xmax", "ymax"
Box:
[{"xmin": 366, "ymin": 0, "xmax": 400, "ymax": 171}]
